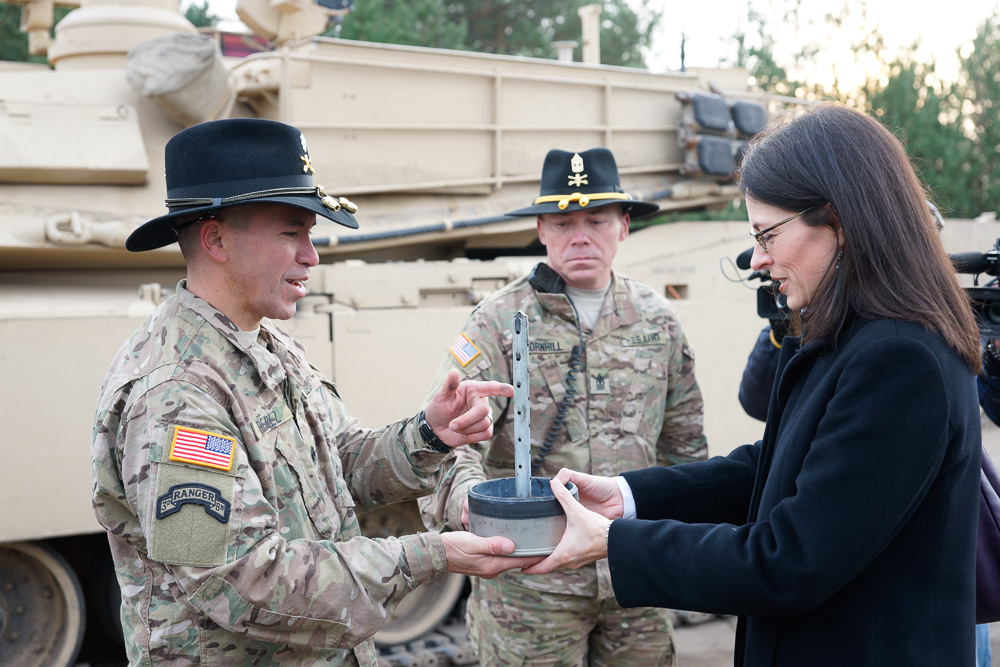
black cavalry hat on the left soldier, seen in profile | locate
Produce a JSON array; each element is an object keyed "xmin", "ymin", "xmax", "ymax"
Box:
[{"xmin": 125, "ymin": 118, "xmax": 358, "ymax": 252}]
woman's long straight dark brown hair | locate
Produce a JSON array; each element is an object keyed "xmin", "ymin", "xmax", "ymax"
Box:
[{"xmin": 739, "ymin": 104, "xmax": 980, "ymax": 372}]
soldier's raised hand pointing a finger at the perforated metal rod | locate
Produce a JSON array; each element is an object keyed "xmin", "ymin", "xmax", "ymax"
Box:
[{"xmin": 424, "ymin": 369, "xmax": 514, "ymax": 447}]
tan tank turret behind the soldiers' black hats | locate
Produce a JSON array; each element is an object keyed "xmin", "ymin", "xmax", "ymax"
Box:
[{"xmin": 0, "ymin": 0, "xmax": 769, "ymax": 269}]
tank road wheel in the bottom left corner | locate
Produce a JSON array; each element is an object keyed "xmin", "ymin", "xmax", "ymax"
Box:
[{"xmin": 0, "ymin": 542, "xmax": 86, "ymax": 667}]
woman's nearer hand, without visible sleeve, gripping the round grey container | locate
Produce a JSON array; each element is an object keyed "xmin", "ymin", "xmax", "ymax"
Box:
[{"xmin": 522, "ymin": 478, "xmax": 617, "ymax": 574}]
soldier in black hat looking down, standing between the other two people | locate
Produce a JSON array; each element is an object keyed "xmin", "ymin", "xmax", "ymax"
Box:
[{"xmin": 419, "ymin": 148, "xmax": 707, "ymax": 667}]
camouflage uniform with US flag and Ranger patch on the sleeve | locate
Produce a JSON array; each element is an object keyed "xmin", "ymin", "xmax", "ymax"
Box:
[{"xmin": 91, "ymin": 281, "xmax": 446, "ymax": 666}]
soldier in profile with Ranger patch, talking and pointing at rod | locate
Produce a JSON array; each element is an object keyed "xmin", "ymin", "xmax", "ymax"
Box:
[{"xmin": 91, "ymin": 119, "xmax": 537, "ymax": 667}]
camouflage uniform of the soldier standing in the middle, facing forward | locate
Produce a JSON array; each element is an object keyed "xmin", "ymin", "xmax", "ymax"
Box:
[{"xmin": 420, "ymin": 274, "xmax": 707, "ymax": 665}]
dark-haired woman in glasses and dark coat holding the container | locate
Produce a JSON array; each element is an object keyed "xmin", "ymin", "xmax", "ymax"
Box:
[{"xmin": 525, "ymin": 105, "xmax": 980, "ymax": 667}]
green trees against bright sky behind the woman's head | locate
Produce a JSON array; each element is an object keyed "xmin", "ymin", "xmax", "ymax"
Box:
[{"xmin": 734, "ymin": 0, "xmax": 1000, "ymax": 218}]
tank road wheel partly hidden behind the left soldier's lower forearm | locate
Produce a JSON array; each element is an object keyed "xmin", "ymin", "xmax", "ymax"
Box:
[{"xmin": 359, "ymin": 502, "xmax": 465, "ymax": 646}]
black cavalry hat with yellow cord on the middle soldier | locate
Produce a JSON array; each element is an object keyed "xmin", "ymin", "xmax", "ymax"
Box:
[{"xmin": 507, "ymin": 148, "xmax": 660, "ymax": 220}]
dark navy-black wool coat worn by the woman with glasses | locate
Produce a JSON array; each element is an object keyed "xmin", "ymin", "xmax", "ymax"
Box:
[{"xmin": 608, "ymin": 320, "xmax": 981, "ymax": 667}]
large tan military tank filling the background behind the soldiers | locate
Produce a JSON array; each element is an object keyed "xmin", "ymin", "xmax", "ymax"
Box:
[{"xmin": 0, "ymin": 0, "xmax": 816, "ymax": 666}]
